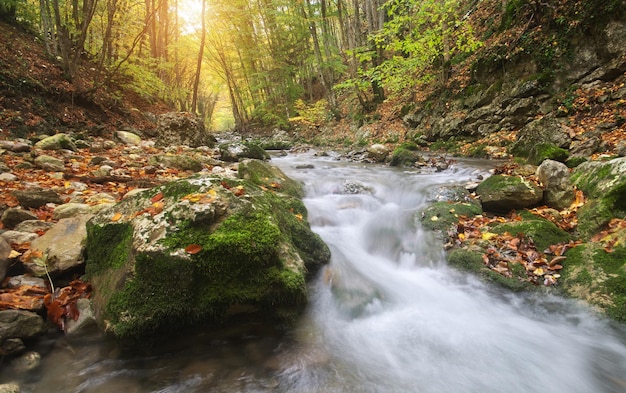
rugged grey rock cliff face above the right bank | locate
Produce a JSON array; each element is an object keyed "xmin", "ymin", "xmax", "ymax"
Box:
[{"xmin": 403, "ymin": 14, "xmax": 626, "ymax": 157}]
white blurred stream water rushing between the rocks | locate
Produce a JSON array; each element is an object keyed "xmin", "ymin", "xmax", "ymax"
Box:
[{"xmin": 7, "ymin": 155, "xmax": 626, "ymax": 393}]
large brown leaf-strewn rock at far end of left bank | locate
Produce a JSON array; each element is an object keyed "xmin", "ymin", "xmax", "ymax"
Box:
[{"xmin": 155, "ymin": 112, "xmax": 216, "ymax": 147}]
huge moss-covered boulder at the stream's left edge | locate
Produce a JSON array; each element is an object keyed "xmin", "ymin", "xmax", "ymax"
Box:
[{"xmin": 86, "ymin": 159, "xmax": 330, "ymax": 342}]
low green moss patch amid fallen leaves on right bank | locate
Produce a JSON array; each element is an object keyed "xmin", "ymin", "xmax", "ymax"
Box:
[{"xmin": 491, "ymin": 218, "xmax": 572, "ymax": 251}]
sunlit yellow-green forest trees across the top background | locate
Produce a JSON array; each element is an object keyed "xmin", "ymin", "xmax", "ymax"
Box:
[{"xmin": 0, "ymin": 0, "xmax": 615, "ymax": 131}]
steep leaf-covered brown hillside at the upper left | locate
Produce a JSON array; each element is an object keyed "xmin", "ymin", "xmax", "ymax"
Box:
[{"xmin": 0, "ymin": 22, "xmax": 167, "ymax": 137}]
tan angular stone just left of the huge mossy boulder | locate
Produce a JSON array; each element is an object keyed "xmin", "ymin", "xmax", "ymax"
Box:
[{"xmin": 24, "ymin": 214, "xmax": 91, "ymax": 277}]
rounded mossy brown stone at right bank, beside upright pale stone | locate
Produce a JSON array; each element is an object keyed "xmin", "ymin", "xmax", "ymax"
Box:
[{"xmin": 476, "ymin": 175, "xmax": 543, "ymax": 212}]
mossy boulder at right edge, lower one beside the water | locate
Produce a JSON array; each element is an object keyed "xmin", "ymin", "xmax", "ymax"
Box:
[{"xmin": 559, "ymin": 242, "xmax": 626, "ymax": 322}]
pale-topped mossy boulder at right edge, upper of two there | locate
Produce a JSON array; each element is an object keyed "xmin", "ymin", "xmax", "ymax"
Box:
[{"xmin": 570, "ymin": 157, "xmax": 626, "ymax": 239}]
